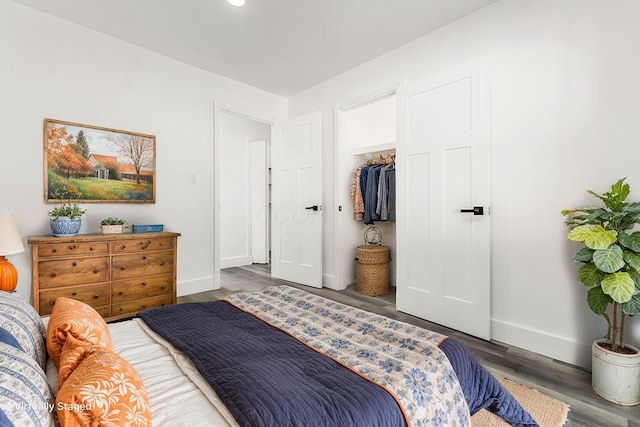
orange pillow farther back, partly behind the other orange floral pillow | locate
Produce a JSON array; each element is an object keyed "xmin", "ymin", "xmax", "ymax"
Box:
[{"xmin": 46, "ymin": 297, "xmax": 112, "ymax": 368}]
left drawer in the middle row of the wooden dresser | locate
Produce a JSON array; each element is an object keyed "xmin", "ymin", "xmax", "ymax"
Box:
[{"xmin": 38, "ymin": 256, "xmax": 109, "ymax": 289}]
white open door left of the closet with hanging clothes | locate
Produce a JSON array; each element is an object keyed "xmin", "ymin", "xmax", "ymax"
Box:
[{"xmin": 271, "ymin": 112, "xmax": 322, "ymax": 288}]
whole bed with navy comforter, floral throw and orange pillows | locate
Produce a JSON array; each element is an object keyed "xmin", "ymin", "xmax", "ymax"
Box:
[{"xmin": 0, "ymin": 285, "xmax": 537, "ymax": 427}]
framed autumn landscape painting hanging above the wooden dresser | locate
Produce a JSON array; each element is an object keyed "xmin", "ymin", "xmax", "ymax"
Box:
[{"xmin": 44, "ymin": 119, "xmax": 156, "ymax": 203}]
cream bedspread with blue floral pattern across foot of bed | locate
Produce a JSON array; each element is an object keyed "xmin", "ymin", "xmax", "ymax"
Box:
[{"xmin": 224, "ymin": 286, "xmax": 470, "ymax": 427}]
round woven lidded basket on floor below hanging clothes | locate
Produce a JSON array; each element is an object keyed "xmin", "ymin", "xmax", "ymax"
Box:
[{"xmin": 356, "ymin": 245, "xmax": 391, "ymax": 296}]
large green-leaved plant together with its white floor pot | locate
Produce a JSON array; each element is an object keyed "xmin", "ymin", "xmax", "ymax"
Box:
[{"xmin": 562, "ymin": 178, "xmax": 640, "ymax": 405}]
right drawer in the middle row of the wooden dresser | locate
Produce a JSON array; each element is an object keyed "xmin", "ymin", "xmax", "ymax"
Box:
[{"xmin": 111, "ymin": 251, "xmax": 174, "ymax": 280}]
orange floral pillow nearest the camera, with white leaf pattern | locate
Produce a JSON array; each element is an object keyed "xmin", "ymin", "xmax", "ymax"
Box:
[{"xmin": 56, "ymin": 346, "xmax": 151, "ymax": 427}]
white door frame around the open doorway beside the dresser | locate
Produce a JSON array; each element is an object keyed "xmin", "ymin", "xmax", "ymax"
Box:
[{"xmin": 213, "ymin": 105, "xmax": 274, "ymax": 289}]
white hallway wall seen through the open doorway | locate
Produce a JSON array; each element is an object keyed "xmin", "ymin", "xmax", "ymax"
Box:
[{"xmin": 220, "ymin": 112, "xmax": 271, "ymax": 268}]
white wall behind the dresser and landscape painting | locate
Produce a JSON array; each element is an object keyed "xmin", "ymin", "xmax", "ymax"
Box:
[{"xmin": 0, "ymin": 0, "xmax": 287, "ymax": 297}]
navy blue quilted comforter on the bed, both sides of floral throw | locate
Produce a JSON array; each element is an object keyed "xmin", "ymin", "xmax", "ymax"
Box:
[{"xmin": 139, "ymin": 288, "xmax": 537, "ymax": 427}]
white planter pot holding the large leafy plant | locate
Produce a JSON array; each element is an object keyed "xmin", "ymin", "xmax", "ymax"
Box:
[{"xmin": 591, "ymin": 340, "xmax": 640, "ymax": 406}]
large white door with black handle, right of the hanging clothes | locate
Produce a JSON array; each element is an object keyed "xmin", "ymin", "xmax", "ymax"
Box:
[{"xmin": 396, "ymin": 66, "xmax": 491, "ymax": 339}]
